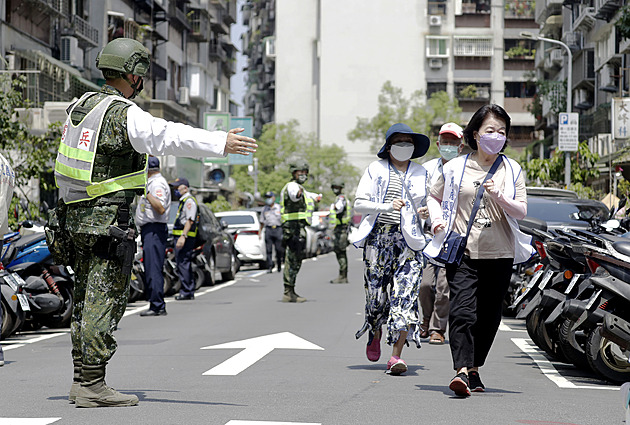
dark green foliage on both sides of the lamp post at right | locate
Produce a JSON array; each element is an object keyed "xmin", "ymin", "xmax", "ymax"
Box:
[{"xmin": 521, "ymin": 141, "xmax": 599, "ymax": 198}]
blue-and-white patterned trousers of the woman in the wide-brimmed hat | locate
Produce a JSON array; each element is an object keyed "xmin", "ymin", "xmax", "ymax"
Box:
[{"xmin": 355, "ymin": 223, "xmax": 423, "ymax": 348}]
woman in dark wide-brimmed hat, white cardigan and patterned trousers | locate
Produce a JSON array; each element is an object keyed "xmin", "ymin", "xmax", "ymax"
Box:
[{"xmin": 353, "ymin": 123, "xmax": 430, "ymax": 375}]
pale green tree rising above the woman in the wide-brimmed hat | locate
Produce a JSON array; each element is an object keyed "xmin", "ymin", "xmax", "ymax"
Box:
[{"xmin": 348, "ymin": 81, "xmax": 462, "ymax": 157}]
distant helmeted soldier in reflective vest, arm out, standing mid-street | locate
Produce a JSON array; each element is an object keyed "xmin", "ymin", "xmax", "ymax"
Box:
[{"xmin": 280, "ymin": 162, "xmax": 321, "ymax": 303}]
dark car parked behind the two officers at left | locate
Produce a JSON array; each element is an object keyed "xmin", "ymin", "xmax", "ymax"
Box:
[{"xmin": 168, "ymin": 202, "xmax": 241, "ymax": 282}]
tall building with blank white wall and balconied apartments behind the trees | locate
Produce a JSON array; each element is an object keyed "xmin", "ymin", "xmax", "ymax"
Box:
[{"xmin": 243, "ymin": 0, "xmax": 538, "ymax": 171}]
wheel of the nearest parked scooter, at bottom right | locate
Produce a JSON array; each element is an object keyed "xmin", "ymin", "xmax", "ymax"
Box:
[{"xmin": 586, "ymin": 325, "xmax": 630, "ymax": 384}]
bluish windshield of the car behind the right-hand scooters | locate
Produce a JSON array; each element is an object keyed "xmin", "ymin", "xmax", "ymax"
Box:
[{"xmin": 527, "ymin": 197, "xmax": 608, "ymax": 224}]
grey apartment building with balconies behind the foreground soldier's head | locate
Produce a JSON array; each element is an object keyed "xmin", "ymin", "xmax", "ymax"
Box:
[{"xmin": 0, "ymin": 0, "xmax": 237, "ymax": 195}]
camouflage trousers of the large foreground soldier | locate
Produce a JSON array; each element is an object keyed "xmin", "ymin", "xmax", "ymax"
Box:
[{"xmin": 70, "ymin": 233, "xmax": 131, "ymax": 365}]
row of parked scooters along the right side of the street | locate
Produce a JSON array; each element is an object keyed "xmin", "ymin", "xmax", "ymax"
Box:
[{"xmin": 507, "ymin": 204, "xmax": 630, "ymax": 383}]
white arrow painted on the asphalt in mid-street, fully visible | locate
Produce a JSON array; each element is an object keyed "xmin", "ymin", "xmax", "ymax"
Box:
[{"xmin": 201, "ymin": 332, "xmax": 323, "ymax": 375}]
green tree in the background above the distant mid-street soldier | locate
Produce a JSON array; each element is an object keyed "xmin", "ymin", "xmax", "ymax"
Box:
[{"xmin": 232, "ymin": 120, "xmax": 360, "ymax": 209}]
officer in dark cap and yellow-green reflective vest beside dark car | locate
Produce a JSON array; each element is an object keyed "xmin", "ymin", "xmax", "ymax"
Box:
[{"xmin": 171, "ymin": 177, "xmax": 199, "ymax": 301}]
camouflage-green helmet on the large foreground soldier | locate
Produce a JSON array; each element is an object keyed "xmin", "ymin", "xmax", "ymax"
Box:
[{"xmin": 96, "ymin": 38, "xmax": 151, "ymax": 77}]
